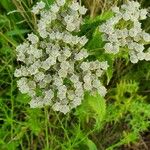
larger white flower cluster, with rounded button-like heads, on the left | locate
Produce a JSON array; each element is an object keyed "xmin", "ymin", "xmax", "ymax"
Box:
[{"xmin": 14, "ymin": 0, "xmax": 108, "ymax": 114}]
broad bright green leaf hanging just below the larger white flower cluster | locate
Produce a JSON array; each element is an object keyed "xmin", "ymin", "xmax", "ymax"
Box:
[{"xmin": 75, "ymin": 93, "xmax": 106, "ymax": 129}]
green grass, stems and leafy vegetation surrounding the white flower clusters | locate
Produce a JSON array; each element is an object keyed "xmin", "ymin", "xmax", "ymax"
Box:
[{"xmin": 0, "ymin": 0, "xmax": 150, "ymax": 150}]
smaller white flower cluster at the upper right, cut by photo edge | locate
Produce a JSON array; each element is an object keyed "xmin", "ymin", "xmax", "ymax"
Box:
[{"xmin": 100, "ymin": 1, "xmax": 150, "ymax": 63}]
